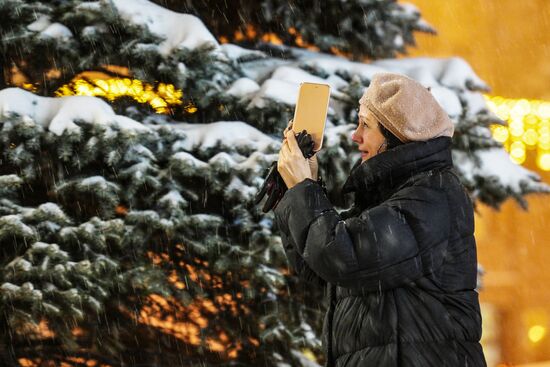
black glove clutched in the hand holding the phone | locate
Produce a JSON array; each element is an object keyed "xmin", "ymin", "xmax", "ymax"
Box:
[{"xmin": 254, "ymin": 130, "xmax": 315, "ymax": 213}]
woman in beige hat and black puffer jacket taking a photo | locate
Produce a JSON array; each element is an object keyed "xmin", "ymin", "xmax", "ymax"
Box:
[{"xmin": 274, "ymin": 73, "xmax": 486, "ymax": 367}]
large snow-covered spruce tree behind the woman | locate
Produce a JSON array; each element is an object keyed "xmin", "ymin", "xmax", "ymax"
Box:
[{"xmin": 0, "ymin": 0, "xmax": 549, "ymax": 366}]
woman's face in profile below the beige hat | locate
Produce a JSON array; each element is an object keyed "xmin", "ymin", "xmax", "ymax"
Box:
[{"xmin": 351, "ymin": 106, "xmax": 386, "ymax": 162}]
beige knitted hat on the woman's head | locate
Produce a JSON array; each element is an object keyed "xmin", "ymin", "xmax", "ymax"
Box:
[{"xmin": 359, "ymin": 73, "xmax": 454, "ymax": 143}]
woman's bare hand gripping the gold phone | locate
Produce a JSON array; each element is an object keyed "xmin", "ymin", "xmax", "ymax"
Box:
[{"xmin": 277, "ymin": 129, "xmax": 313, "ymax": 189}]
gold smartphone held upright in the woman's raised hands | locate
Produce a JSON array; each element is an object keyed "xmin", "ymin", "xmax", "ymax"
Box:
[{"xmin": 292, "ymin": 82, "xmax": 330, "ymax": 152}]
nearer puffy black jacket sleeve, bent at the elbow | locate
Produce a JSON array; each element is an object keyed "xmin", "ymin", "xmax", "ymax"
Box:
[{"xmin": 275, "ymin": 179, "xmax": 422, "ymax": 291}]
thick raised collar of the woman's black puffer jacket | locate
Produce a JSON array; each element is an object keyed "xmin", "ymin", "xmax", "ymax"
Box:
[{"xmin": 342, "ymin": 136, "xmax": 453, "ymax": 207}]
